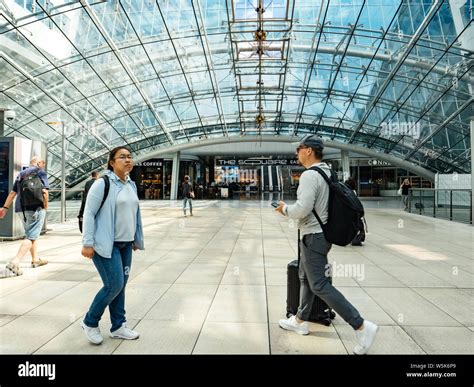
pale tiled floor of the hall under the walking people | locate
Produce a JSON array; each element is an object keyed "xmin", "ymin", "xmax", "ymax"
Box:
[{"xmin": 0, "ymin": 201, "xmax": 474, "ymax": 354}]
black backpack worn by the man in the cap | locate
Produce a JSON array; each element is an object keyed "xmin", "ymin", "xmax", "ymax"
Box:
[{"xmin": 309, "ymin": 167, "xmax": 364, "ymax": 246}]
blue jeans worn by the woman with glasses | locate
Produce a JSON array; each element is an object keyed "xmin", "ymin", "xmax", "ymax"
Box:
[{"xmin": 84, "ymin": 242, "xmax": 133, "ymax": 332}]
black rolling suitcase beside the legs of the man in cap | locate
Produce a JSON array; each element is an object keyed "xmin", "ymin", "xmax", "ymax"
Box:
[{"xmin": 286, "ymin": 230, "xmax": 336, "ymax": 326}]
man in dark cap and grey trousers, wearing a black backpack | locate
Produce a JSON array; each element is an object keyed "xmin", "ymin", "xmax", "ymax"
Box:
[{"xmin": 276, "ymin": 135, "xmax": 378, "ymax": 355}]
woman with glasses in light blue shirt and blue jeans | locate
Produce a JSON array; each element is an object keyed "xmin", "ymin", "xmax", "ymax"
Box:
[{"xmin": 81, "ymin": 146, "xmax": 144, "ymax": 345}]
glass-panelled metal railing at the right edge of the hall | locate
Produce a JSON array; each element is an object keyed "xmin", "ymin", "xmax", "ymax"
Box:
[{"xmin": 408, "ymin": 188, "xmax": 472, "ymax": 224}]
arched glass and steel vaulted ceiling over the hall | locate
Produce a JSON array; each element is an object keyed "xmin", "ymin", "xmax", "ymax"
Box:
[{"xmin": 0, "ymin": 0, "xmax": 474, "ymax": 186}]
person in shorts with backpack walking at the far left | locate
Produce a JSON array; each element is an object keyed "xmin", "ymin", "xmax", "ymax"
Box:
[{"xmin": 0, "ymin": 156, "xmax": 49, "ymax": 276}]
